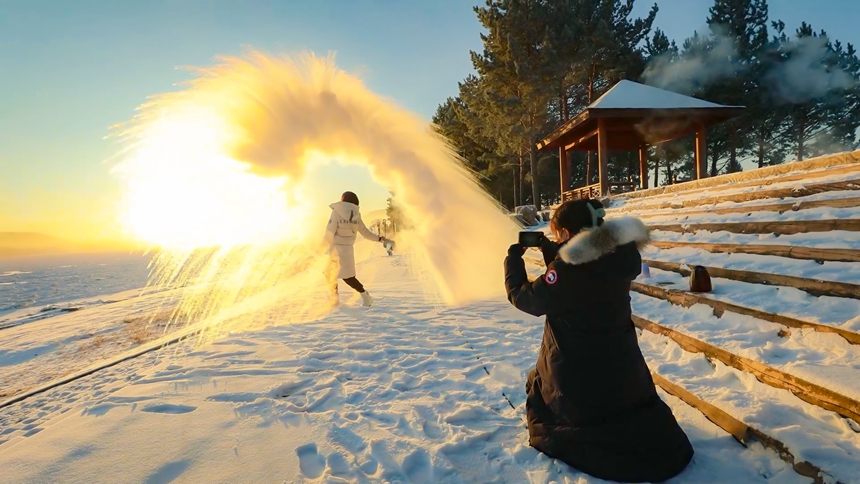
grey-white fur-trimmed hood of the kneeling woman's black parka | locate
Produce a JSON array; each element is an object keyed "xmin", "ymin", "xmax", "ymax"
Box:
[{"xmin": 558, "ymin": 217, "xmax": 651, "ymax": 265}]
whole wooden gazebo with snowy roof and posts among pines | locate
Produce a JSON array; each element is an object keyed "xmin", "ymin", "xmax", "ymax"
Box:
[{"xmin": 537, "ymin": 81, "xmax": 744, "ymax": 201}]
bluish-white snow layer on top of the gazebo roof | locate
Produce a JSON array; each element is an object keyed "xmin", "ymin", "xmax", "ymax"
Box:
[{"xmin": 588, "ymin": 80, "xmax": 728, "ymax": 109}]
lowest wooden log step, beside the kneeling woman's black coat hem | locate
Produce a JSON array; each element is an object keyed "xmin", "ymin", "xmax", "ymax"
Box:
[{"xmin": 651, "ymin": 372, "xmax": 838, "ymax": 484}]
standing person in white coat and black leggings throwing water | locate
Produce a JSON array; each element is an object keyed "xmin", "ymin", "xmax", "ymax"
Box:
[{"xmin": 325, "ymin": 192, "xmax": 385, "ymax": 306}]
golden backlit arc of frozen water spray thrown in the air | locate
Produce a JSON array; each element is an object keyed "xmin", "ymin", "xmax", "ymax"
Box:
[{"xmin": 114, "ymin": 52, "xmax": 517, "ymax": 342}]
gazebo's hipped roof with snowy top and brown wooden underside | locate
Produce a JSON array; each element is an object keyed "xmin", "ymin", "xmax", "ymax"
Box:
[{"xmin": 537, "ymin": 80, "xmax": 744, "ymax": 151}]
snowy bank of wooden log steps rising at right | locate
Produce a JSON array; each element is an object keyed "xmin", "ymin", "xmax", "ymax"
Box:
[{"xmin": 531, "ymin": 151, "xmax": 860, "ymax": 482}]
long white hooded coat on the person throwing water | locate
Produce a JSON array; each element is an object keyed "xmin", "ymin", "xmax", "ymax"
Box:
[{"xmin": 325, "ymin": 202, "xmax": 382, "ymax": 279}]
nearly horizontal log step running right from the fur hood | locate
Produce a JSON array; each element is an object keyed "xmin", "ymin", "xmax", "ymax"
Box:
[{"xmin": 648, "ymin": 218, "xmax": 860, "ymax": 235}]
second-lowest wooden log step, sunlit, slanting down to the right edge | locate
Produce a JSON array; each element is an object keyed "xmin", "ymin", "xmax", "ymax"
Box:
[{"xmin": 632, "ymin": 315, "xmax": 860, "ymax": 423}]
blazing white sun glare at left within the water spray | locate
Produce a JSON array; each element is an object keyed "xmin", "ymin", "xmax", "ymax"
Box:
[{"xmin": 109, "ymin": 109, "xmax": 306, "ymax": 250}]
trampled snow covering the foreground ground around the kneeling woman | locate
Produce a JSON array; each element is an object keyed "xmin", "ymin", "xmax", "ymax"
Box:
[{"xmin": 0, "ymin": 243, "xmax": 832, "ymax": 483}]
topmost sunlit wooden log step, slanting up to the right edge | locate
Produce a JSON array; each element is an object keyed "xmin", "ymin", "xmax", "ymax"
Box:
[{"xmin": 623, "ymin": 150, "xmax": 860, "ymax": 199}]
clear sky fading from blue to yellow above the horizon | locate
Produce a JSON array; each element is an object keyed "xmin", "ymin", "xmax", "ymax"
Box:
[{"xmin": 0, "ymin": 0, "xmax": 860, "ymax": 244}]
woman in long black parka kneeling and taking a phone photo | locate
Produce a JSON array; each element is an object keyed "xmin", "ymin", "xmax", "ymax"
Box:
[{"xmin": 505, "ymin": 200, "xmax": 693, "ymax": 482}]
